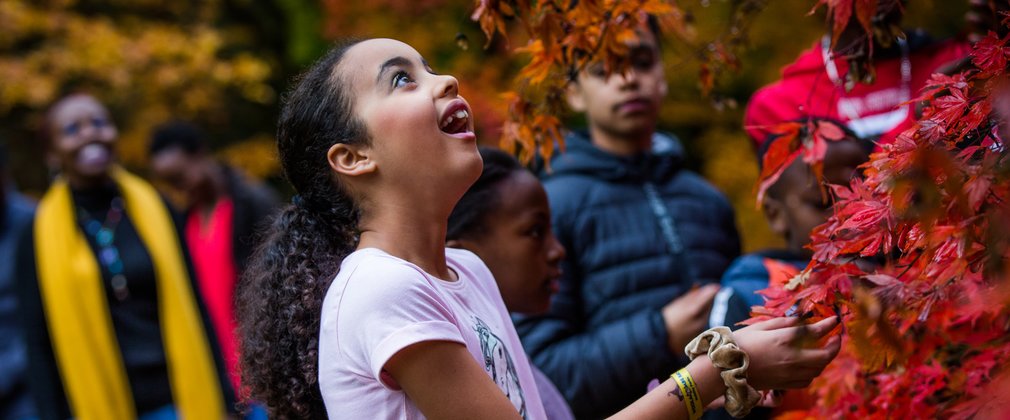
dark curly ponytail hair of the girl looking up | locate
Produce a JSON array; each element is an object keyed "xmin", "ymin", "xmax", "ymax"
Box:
[{"xmin": 235, "ymin": 40, "xmax": 370, "ymax": 419}]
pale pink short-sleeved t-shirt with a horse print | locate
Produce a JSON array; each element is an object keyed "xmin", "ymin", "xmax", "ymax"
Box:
[{"xmin": 319, "ymin": 248, "xmax": 546, "ymax": 419}]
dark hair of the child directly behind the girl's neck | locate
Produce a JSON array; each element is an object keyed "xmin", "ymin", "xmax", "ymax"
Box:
[{"xmin": 445, "ymin": 146, "xmax": 525, "ymax": 240}]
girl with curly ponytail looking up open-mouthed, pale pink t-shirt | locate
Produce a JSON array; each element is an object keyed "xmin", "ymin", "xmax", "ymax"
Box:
[{"xmin": 237, "ymin": 39, "xmax": 837, "ymax": 419}]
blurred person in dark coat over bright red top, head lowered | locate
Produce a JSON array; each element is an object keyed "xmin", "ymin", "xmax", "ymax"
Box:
[{"xmin": 148, "ymin": 120, "xmax": 280, "ymax": 419}]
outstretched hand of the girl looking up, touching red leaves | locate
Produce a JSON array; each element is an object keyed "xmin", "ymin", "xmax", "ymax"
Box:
[{"xmin": 733, "ymin": 317, "xmax": 841, "ymax": 390}]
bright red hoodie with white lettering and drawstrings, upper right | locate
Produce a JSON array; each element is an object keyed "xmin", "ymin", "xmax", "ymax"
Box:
[{"xmin": 743, "ymin": 0, "xmax": 969, "ymax": 143}]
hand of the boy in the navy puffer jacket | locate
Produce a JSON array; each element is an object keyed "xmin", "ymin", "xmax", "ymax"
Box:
[{"xmin": 662, "ymin": 285, "xmax": 719, "ymax": 354}]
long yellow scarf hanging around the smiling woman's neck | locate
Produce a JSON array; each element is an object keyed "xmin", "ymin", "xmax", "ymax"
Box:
[{"xmin": 34, "ymin": 170, "xmax": 225, "ymax": 420}]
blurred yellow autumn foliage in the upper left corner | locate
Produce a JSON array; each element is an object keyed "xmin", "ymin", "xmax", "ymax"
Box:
[{"xmin": 0, "ymin": 0, "xmax": 277, "ymax": 186}]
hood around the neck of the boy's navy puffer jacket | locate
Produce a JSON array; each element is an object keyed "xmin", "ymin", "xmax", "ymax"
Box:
[{"xmin": 549, "ymin": 131, "xmax": 685, "ymax": 183}]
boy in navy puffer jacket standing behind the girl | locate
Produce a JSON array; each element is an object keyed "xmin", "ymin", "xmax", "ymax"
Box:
[{"xmin": 516, "ymin": 18, "xmax": 739, "ymax": 418}]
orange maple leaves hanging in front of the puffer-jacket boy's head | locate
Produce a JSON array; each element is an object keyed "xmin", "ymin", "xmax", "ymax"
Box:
[{"xmin": 472, "ymin": 0, "xmax": 686, "ymax": 162}]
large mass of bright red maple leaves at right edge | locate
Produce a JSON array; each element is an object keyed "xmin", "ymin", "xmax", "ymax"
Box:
[{"xmin": 756, "ymin": 14, "xmax": 1010, "ymax": 418}]
